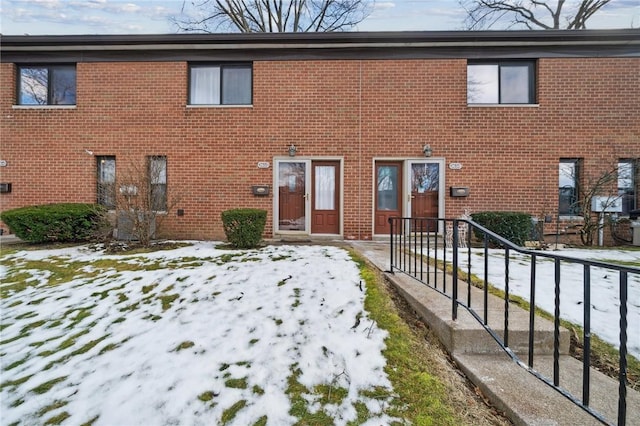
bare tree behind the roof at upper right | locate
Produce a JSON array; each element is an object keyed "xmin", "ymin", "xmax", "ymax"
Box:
[{"xmin": 458, "ymin": 0, "xmax": 611, "ymax": 30}]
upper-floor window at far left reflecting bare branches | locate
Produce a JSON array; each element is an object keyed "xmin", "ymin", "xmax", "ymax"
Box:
[{"xmin": 18, "ymin": 65, "xmax": 76, "ymax": 105}]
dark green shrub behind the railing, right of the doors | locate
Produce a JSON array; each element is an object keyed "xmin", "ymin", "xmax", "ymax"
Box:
[{"xmin": 471, "ymin": 212, "xmax": 532, "ymax": 246}]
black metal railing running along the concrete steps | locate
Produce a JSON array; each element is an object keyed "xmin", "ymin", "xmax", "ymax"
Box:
[{"xmin": 389, "ymin": 217, "xmax": 640, "ymax": 425}]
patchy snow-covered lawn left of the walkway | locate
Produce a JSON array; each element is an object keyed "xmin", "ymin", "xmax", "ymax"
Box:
[{"xmin": 0, "ymin": 242, "xmax": 392, "ymax": 426}]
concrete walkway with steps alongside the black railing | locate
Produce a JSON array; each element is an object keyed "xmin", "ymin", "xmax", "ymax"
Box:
[{"xmin": 349, "ymin": 241, "xmax": 640, "ymax": 426}]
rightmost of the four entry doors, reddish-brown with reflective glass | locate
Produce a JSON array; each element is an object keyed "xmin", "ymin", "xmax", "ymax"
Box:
[{"xmin": 409, "ymin": 162, "xmax": 440, "ymax": 232}]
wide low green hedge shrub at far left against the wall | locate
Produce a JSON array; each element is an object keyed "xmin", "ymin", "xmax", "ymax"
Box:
[{"xmin": 0, "ymin": 203, "xmax": 106, "ymax": 243}]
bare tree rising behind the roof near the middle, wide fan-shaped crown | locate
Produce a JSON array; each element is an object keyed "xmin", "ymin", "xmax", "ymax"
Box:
[{"xmin": 170, "ymin": 0, "xmax": 372, "ymax": 33}]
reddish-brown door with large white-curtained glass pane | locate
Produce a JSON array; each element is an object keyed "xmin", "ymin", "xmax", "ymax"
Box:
[{"xmin": 311, "ymin": 161, "xmax": 340, "ymax": 234}]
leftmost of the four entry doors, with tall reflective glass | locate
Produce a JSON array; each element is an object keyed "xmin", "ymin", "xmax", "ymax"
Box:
[{"xmin": 277, "ymin": 161, "xmax": 308, "ymax": 231}]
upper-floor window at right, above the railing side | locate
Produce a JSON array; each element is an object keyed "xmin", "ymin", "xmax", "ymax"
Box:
[{"xmin": 467, "ymin": 61, "xmax": 536, "ymax": 104}]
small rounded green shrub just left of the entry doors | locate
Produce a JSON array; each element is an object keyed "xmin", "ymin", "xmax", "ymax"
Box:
[{"xmin": 222, "ymin": 209, "xmax": 267, "ymax": 248}]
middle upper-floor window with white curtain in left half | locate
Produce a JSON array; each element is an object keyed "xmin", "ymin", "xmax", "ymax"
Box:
[{"xmin": 189, "ymin": 64, "xmax": 252, "ymax": 105}]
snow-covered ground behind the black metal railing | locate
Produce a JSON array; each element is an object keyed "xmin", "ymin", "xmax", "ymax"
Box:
[{"xmin": 438, "ymin": 249, "xmax": 640, "ymax": 359}]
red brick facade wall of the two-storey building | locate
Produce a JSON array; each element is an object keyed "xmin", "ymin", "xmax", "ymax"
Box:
[{"xmin": 0, "ymin": 58, "xmax": 640, "ymax": 239}]
